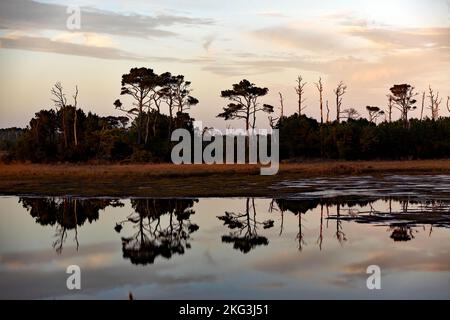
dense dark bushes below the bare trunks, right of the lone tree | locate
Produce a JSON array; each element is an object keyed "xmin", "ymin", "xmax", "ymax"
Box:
[{"xmin": 279, "ymin": 114, "xmax": 450, "ymax": 160}]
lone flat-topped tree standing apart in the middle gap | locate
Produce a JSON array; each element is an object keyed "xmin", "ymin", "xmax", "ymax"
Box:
[{"xmin": 217, "ymin": 79, "xmax": 274, "ymax": 130}]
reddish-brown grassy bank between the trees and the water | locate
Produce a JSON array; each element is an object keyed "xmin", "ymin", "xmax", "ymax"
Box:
[{"xmin": 0, "ymin": 160, "xmax": 450, "ymax": 197}]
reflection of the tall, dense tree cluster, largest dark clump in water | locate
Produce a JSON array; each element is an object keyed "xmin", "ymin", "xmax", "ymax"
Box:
[{"xmin": 114, "ymin": 199, "xmax": 199, "ymax": 265}]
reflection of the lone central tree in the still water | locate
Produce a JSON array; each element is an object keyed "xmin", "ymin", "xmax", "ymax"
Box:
[{"xmin": 217, "ymin": 198, "xmax": 274, "ymax": 254}]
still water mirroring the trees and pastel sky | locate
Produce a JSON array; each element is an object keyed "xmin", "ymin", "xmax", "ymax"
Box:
[{"xmin": 0, "ymin": 175, "xmax": 450, "ymax": 299}]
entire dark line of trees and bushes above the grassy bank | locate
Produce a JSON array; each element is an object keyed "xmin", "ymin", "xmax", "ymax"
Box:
[{"xmin": 0, "ymin": 68, "xmax": 450, "ymax": 162}]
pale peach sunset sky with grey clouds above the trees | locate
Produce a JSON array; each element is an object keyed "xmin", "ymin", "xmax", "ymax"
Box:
[{"xmin": 0, "ymin": 0, "xmax": 450, "ymax": 128}]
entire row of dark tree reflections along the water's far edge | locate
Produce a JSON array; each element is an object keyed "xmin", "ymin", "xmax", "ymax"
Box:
[{"xmin": 19, "ymin": 196, "xmax": 450, "ymax": 265}]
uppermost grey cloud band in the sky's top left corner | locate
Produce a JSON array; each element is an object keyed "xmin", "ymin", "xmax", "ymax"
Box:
[{"xmin": 0, "ymin": 0, "xmax": 214, "ymax": 38}]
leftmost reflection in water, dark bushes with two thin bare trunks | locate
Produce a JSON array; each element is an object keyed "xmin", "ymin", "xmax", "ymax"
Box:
[{"xmin": 19, "ymin": 197, "xmax": 123, "ymax": 254}]
